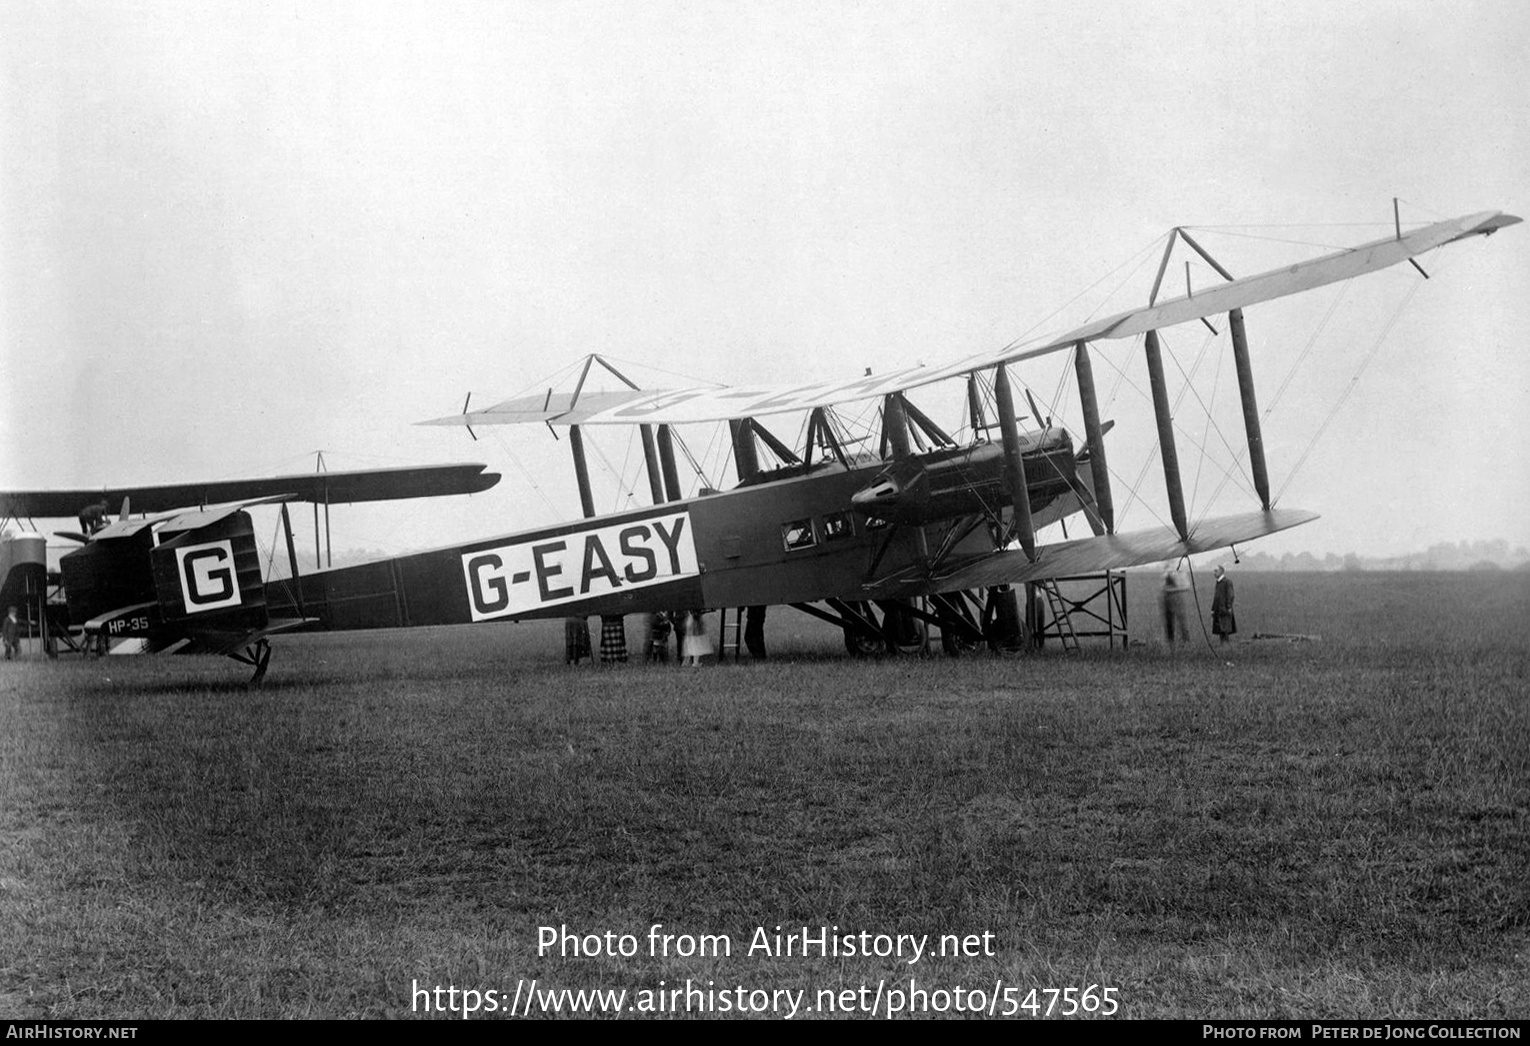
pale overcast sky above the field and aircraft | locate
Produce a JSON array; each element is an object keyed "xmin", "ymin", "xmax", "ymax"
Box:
[{"xmin": 0, "ymin": 0, "xmax": 1530, "ymax": 555}]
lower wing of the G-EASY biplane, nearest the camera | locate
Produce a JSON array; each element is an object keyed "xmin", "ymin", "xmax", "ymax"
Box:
[{"xmin": 877, "ymin": 509, "xmax": 1317, "ymax": 599}]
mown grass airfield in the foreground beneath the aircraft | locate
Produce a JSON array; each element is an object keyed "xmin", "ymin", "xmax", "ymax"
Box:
[{"xmin": 0, "ymin": 572, "xmax": 1530, "ymax": 1018}]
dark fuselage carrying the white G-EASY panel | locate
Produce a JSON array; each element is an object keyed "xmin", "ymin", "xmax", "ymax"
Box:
[{"xmin": 266, "ymin": 440, "xmax": 1076, "ymax": 629}]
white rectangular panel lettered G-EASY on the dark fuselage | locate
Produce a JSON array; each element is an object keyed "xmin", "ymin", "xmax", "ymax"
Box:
[{"xmin": 462, "ymin": 512, "xmax": 699, "ymax": 621}]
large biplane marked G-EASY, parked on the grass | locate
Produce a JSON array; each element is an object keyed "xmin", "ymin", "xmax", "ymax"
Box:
[{"xmin": 0, "ymin": 211, "xmax": 1521, "ymax": 682}]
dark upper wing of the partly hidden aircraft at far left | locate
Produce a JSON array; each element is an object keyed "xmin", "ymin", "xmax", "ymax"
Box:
[{"xmin": 0, "ymin": 465, "xmax": 499, "ymax": 520}]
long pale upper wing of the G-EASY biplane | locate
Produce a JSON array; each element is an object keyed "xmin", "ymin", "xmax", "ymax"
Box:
[{"xmin": 421, "ymin": 211, "xmax": 1521, "ymax": 425}]
